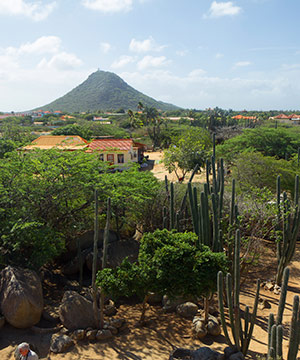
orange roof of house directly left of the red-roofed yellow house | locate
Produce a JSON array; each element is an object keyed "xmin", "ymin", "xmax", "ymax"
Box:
[{"xmin": 22, "ymin": 135, "xmax": 88, "ymax": 151}]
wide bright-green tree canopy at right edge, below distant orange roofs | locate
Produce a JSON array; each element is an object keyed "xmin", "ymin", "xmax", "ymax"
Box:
[{"xmin": 217, "ymin": 127, "xmax": 300, "ymax": 163}]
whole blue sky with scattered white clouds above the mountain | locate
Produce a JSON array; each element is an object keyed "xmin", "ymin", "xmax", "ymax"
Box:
[{"xmin": 0, "ymin": 0, "xmax": 300, "ymax": 111}]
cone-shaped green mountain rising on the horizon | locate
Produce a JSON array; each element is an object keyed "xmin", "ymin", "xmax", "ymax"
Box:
[{"xmin": 39, "ymin": 70, "xmax": 178, "ymax": 112}]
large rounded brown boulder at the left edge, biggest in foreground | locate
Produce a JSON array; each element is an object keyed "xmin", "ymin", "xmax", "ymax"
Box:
[{"xmin": 0, "ymin": 266, "xmax": 44, "ymax": 328}]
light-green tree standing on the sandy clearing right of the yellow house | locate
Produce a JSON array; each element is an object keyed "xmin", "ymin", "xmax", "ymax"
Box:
[{"xmin": 163, "ymin": 129, "xmax": 211, "ymax": 180}]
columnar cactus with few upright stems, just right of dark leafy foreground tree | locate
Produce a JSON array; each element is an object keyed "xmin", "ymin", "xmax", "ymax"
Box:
[{"xmin": 218, "ymin": 230, "xmax": 260, "ymax": 356}]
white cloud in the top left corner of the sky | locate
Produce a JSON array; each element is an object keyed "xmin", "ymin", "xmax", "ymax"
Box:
[{"xmin": 0, "ymin": 0, "xmax": 56, "ymax": 21}]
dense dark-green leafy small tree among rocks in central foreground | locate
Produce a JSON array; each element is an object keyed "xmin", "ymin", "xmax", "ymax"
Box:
[{"xmin": 97, "ymin": 229, "xmax": 227, "ymax": 321}]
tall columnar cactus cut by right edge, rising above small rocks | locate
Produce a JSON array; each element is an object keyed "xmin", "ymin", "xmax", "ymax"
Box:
[{"xmin": 275, "ymin": 175, "xmax": 300, "ymax": 285}]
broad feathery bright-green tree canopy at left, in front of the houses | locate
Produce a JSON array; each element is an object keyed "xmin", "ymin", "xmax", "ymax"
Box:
[{"xmin": 0, "ymin": 150, "xmax": 159, "ymax": 266}]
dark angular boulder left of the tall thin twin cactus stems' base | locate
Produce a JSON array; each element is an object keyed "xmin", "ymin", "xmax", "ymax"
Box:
[{"xmin": 59, "ymin": 291, "xmax": 95, "ymax": 330}]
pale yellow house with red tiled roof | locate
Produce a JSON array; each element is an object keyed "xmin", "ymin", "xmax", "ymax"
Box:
[{"xmin": 88, "ymin": 139, "xmax": 145, "ymax": 165}]
